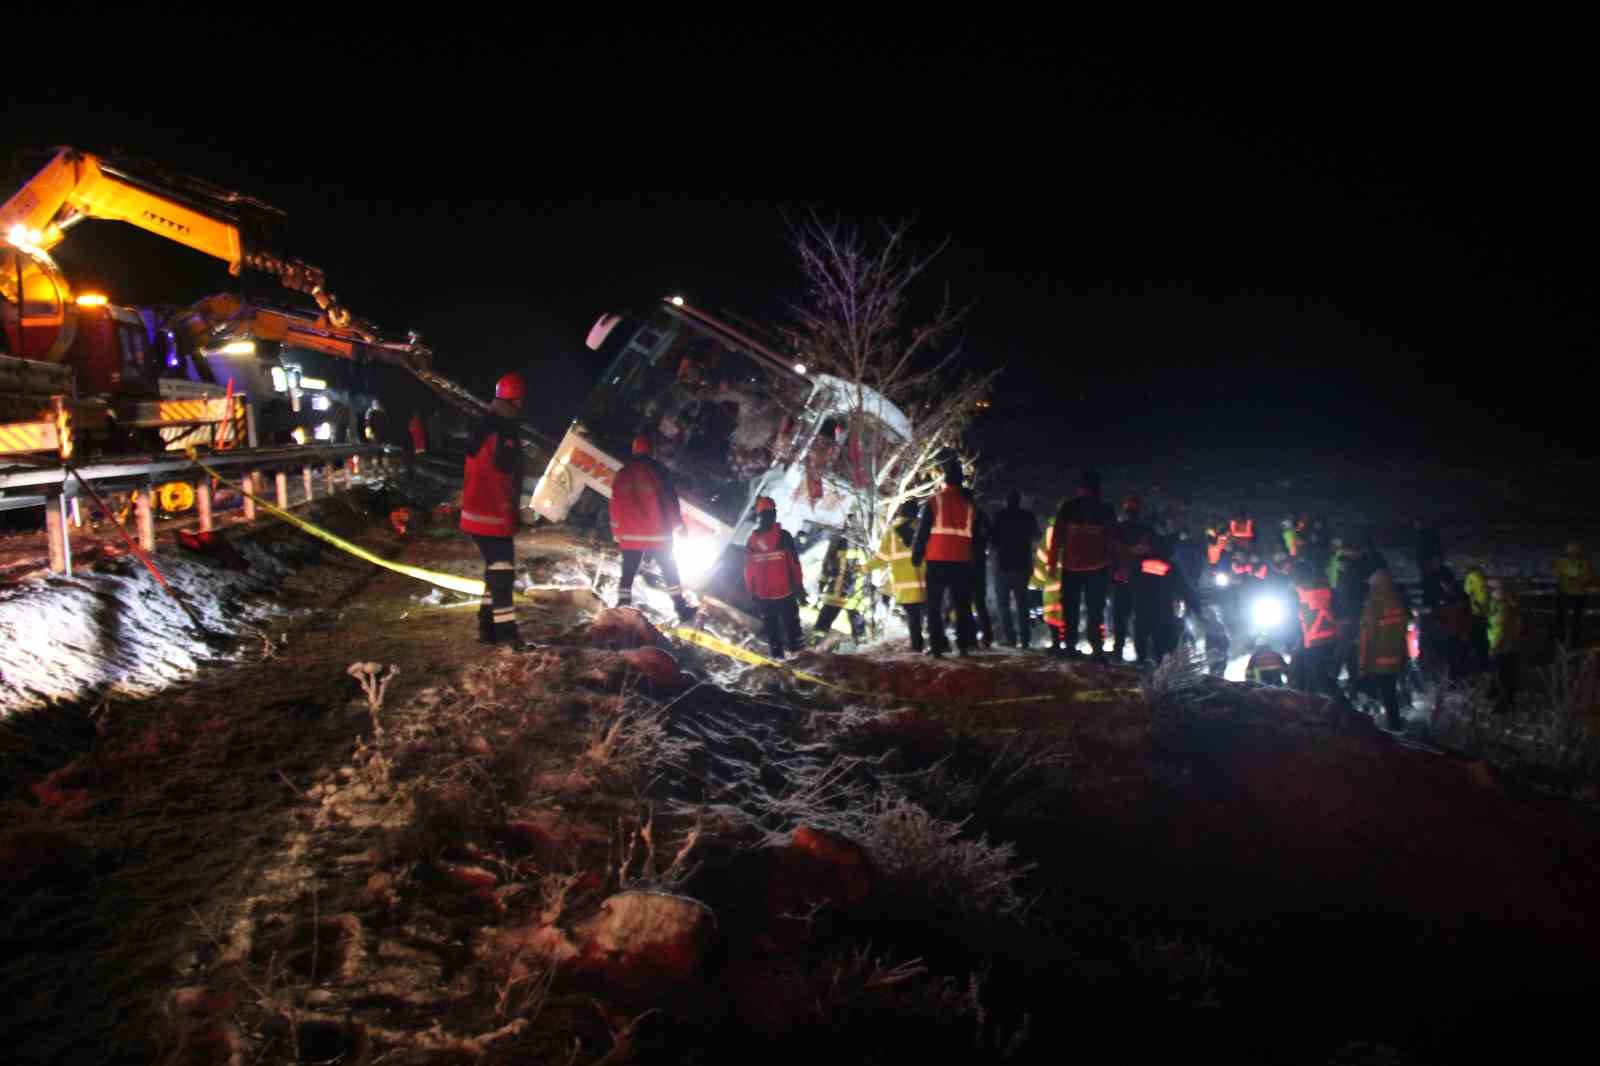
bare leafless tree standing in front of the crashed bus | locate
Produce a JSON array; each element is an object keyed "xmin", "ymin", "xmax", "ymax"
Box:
[{"xmin": 789, "ymin": 216, "xmax": 997, "ymax": 552}]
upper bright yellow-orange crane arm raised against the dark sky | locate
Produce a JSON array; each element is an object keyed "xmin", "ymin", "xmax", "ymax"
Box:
[{"xmin": 0, "ymin": 147, "xmax": 354, "ymax": 328}]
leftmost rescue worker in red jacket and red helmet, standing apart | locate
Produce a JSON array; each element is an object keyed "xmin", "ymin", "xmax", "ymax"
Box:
[{"xmin": 461, "ymin": 373, "xmax": 530, "ymax": 651}]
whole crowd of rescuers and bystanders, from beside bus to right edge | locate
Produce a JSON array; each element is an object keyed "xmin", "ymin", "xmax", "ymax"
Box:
[{"xmin": 461, "ymin": 390, "xmax": 1595, "ymax": 727}]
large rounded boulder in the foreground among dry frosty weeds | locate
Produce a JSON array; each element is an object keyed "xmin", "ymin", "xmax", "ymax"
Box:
[{"xmin": 573, "ymin": 892, "xmax": 717, "ymax": 1002}]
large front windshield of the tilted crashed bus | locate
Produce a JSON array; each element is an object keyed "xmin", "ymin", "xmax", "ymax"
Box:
[{"xmin": 578, "ymin": 306, "xmax": 811, "ymax": 525}]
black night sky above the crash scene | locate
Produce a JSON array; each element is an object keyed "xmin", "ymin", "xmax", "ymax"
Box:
[{"xmin": 5, "ymin": 8, "xmax": 1600, "ymax": 451}]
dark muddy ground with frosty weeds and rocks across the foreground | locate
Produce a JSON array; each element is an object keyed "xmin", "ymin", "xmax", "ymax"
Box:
[{"xmin": 0, "ymin": 483, "xmax": 1600, "ymax": 1063}]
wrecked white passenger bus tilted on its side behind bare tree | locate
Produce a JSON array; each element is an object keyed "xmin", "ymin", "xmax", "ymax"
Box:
[{"xmin": 531, "ymin": 296, "xmax": 910, "ymax": 587}]
